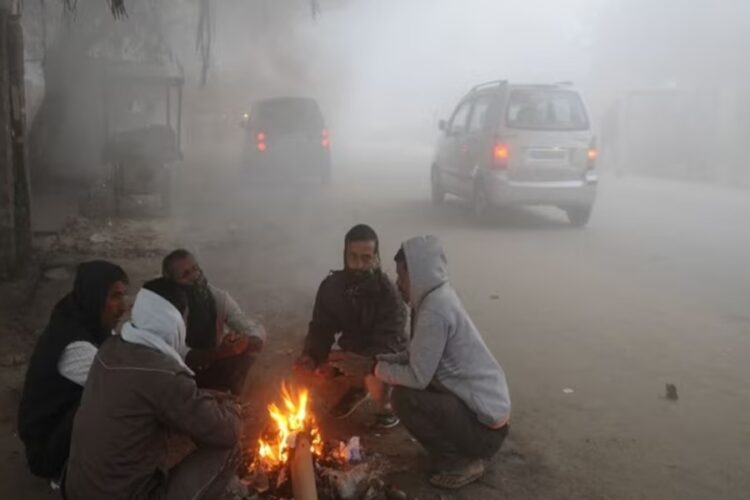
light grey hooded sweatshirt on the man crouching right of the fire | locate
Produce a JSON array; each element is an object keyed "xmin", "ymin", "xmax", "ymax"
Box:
[{"xmin": 375, "ymin": 236, "xmax": 510, "ymax": 427}]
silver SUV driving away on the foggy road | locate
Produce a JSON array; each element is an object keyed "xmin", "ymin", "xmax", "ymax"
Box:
[{"xmin": 431, "ymin": 80, "xmax": 597, "ymax": 226}]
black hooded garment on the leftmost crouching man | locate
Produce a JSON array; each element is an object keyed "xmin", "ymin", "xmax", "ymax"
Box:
[{"xmin": 18, "ymin": 261, "xmax": 128, "ymax": 477}]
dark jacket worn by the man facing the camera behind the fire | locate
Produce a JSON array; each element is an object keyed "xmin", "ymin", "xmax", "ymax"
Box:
[{"xmin": 303, "ymin": 271, "xmax": 407, "ymax": 364}]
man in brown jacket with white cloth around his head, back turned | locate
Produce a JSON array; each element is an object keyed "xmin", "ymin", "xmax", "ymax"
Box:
[{"xmin": 65, "ymin": 278, "xmax": 240, "ymax": 500}]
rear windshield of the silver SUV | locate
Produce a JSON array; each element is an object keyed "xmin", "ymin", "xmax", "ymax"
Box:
[{"xmin": 506, "ymin": 89, "xmax": 589, "ymax": 130}]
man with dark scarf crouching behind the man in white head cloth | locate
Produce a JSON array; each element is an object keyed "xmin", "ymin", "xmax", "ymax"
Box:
[{"xmin": 162, "ymin": 249, "xmax": 266, "ymax": 395}]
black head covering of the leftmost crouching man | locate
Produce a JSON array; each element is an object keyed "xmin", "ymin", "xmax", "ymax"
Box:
[{"xmin": 69, "ymin": 260, "xmax": 128, "ymax": 343}]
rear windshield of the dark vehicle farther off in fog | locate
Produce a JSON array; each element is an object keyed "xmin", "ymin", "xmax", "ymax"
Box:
[{"xmin": 252, "ymin": 99, "xmax": 324, "ymax": 133}]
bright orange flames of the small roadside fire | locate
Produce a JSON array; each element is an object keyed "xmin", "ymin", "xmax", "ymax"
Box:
[{"xmin": 257, "ymin": 382, "xmax": 323, "ymax": 468}]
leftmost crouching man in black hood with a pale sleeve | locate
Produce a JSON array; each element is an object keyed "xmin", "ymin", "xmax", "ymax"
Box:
[{"xmin": 18, "ymin": 261, "xmax": 128, "ymax": 482}]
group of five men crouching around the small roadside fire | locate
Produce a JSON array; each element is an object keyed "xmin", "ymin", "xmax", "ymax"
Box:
[{"xmin": 18, "ymin": 228, "xmax": 510, "ymax": 500}]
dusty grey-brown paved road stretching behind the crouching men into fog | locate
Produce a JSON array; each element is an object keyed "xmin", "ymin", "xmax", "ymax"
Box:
[{"xmin": 175, "ymin": 150, "xmax": 750, "ymax": 499}]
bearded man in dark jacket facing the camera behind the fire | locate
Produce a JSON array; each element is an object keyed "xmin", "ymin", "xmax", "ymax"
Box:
[{"xmin": 296, "ymin": 224, "xmax": 406, "ymax": 428}]
